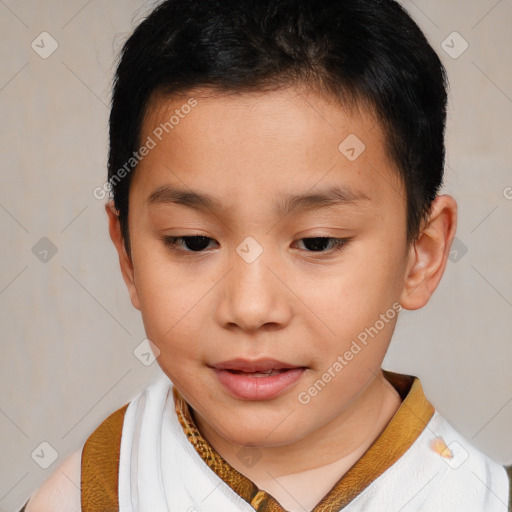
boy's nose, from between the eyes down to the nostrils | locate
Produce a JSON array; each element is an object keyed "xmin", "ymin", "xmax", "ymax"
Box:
[{"xmin": 216, "ymin": 242, "xmax": 293, "ymax": 332}]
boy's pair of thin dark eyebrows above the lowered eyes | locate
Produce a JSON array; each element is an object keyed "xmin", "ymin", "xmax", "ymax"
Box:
[{"xmin": 147, "ymin": 185, "xmax": 370, "ymax": 216}]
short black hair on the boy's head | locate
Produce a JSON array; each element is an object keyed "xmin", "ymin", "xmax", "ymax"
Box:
[{"xmin": 108, "ymin": 0, "xmax": 448, "ymax": 253}]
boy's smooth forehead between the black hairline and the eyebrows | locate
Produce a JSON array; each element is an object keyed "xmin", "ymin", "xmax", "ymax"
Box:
[{"xmin": 130, "ymin": 88, "xmax": 403, "ymax": 213}]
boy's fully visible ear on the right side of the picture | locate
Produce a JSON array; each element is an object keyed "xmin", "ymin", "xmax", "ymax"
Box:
[{"xmin": 400, "ymin": 195, "xmax": 457, "ymax": 310}]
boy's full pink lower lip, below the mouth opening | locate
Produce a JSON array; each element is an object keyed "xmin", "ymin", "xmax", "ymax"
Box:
[{"xmin": 211, "ymin": 368, "xmax": 304, "ymax": 400}]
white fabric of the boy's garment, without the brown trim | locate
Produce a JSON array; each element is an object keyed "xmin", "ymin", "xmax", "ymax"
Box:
[{"xmin": 119, "ymin": 376, "xmax": 509, "ymax": 512}]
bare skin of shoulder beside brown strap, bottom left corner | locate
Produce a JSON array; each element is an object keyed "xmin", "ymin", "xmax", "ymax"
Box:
[{"xmin": 24, "ymin": 449, "xmax": 82, "ymax": 512}]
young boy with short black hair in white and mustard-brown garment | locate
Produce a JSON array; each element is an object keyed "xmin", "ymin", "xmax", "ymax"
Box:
[{"xmin": 26, "ymin": 0, "xmax": 510, "ymax": 512}]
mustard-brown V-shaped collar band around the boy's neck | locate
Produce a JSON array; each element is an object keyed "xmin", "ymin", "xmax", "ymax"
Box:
[{"xmin": 173, "ymin": 370, "xmax": 434, "ymax": 512}]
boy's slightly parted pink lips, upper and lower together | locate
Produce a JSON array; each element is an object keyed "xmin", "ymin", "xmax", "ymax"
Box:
[{"xmin": 211, "ymin": 359, "xmax": 306, "ymax": 400}]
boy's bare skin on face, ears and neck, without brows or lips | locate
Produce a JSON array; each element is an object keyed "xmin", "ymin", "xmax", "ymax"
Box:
[{"xmin": 24, "ymin": 88, "xmax": 457, "ymax": 510}]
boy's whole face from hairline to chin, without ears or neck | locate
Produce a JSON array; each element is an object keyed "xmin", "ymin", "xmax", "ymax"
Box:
[{"xmin": 123, "ymin": 89, "xmax": 410, "ymax": 446}]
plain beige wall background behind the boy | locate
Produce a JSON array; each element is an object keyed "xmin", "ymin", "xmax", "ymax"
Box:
[{"xmin": 0, "ymin": 0, "xmax": 512, "ymax": 511}]
